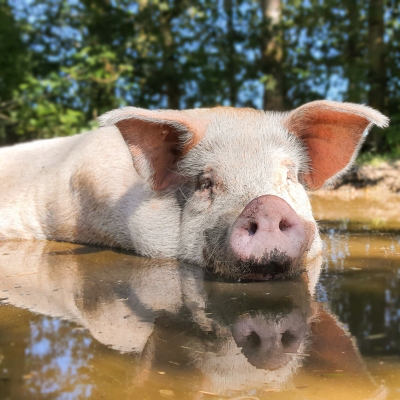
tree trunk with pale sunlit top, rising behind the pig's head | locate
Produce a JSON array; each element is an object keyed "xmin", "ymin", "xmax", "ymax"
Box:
[{"xmin": 260, "ymin": 0, "xmax": 285, "ymax": 111}]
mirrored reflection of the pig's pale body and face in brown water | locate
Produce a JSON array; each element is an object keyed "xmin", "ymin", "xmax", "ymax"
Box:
[{"xmin": 0, "ymin": 242, "xmax": 376, "ymax": 394}]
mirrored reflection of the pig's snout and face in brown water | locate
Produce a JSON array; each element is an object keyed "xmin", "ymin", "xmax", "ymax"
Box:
[{"xmin": 177, "ymin": 268, "xmax": 313, "ymax": 393}]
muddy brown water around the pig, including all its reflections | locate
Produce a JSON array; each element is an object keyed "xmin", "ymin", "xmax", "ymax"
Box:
[{"xmin": 0, "ymin": 198, "xmax": 400, "ymax": 400}]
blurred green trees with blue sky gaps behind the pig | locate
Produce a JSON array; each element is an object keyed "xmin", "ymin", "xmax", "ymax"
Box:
[{"xmin": 0, "ymin": 0, "xmax": 400, "ymax": 153}]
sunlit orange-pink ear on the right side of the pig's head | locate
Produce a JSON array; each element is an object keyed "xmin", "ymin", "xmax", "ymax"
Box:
[{"xmin": 283, "ymin": 100, "xmax": 389, "ymax": 189}]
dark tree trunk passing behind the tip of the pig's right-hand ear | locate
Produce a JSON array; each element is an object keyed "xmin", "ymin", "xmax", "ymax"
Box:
[{"xmin": 367, "ymin": 0, "xmax": 386, "ymax": 152}]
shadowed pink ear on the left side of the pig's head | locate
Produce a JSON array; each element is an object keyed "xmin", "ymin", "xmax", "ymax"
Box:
[{"xmin": 99, "ymin": 107, "xmax": 208, "ymax": 190}]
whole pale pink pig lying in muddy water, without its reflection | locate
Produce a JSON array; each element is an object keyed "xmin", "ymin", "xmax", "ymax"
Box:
[{"xmin": 0, "ymin": 100, "xmax": 388, "ymax": 280}]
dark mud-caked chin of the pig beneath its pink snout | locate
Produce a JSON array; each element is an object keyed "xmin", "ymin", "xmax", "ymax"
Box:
[{"xmin": 205, "ymin": 249, "xmax": 303, "ymax": 281}]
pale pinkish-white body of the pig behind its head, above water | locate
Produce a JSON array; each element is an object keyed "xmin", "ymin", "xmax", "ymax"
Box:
[{"xmin": 0, "ymin": 127, "xmax": 180, "ymax": 257}]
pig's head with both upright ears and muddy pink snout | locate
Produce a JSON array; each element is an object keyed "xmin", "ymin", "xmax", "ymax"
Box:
[{"xmin": 100, "ymin": 101, "xmax": 388, "ymax": 279}]
